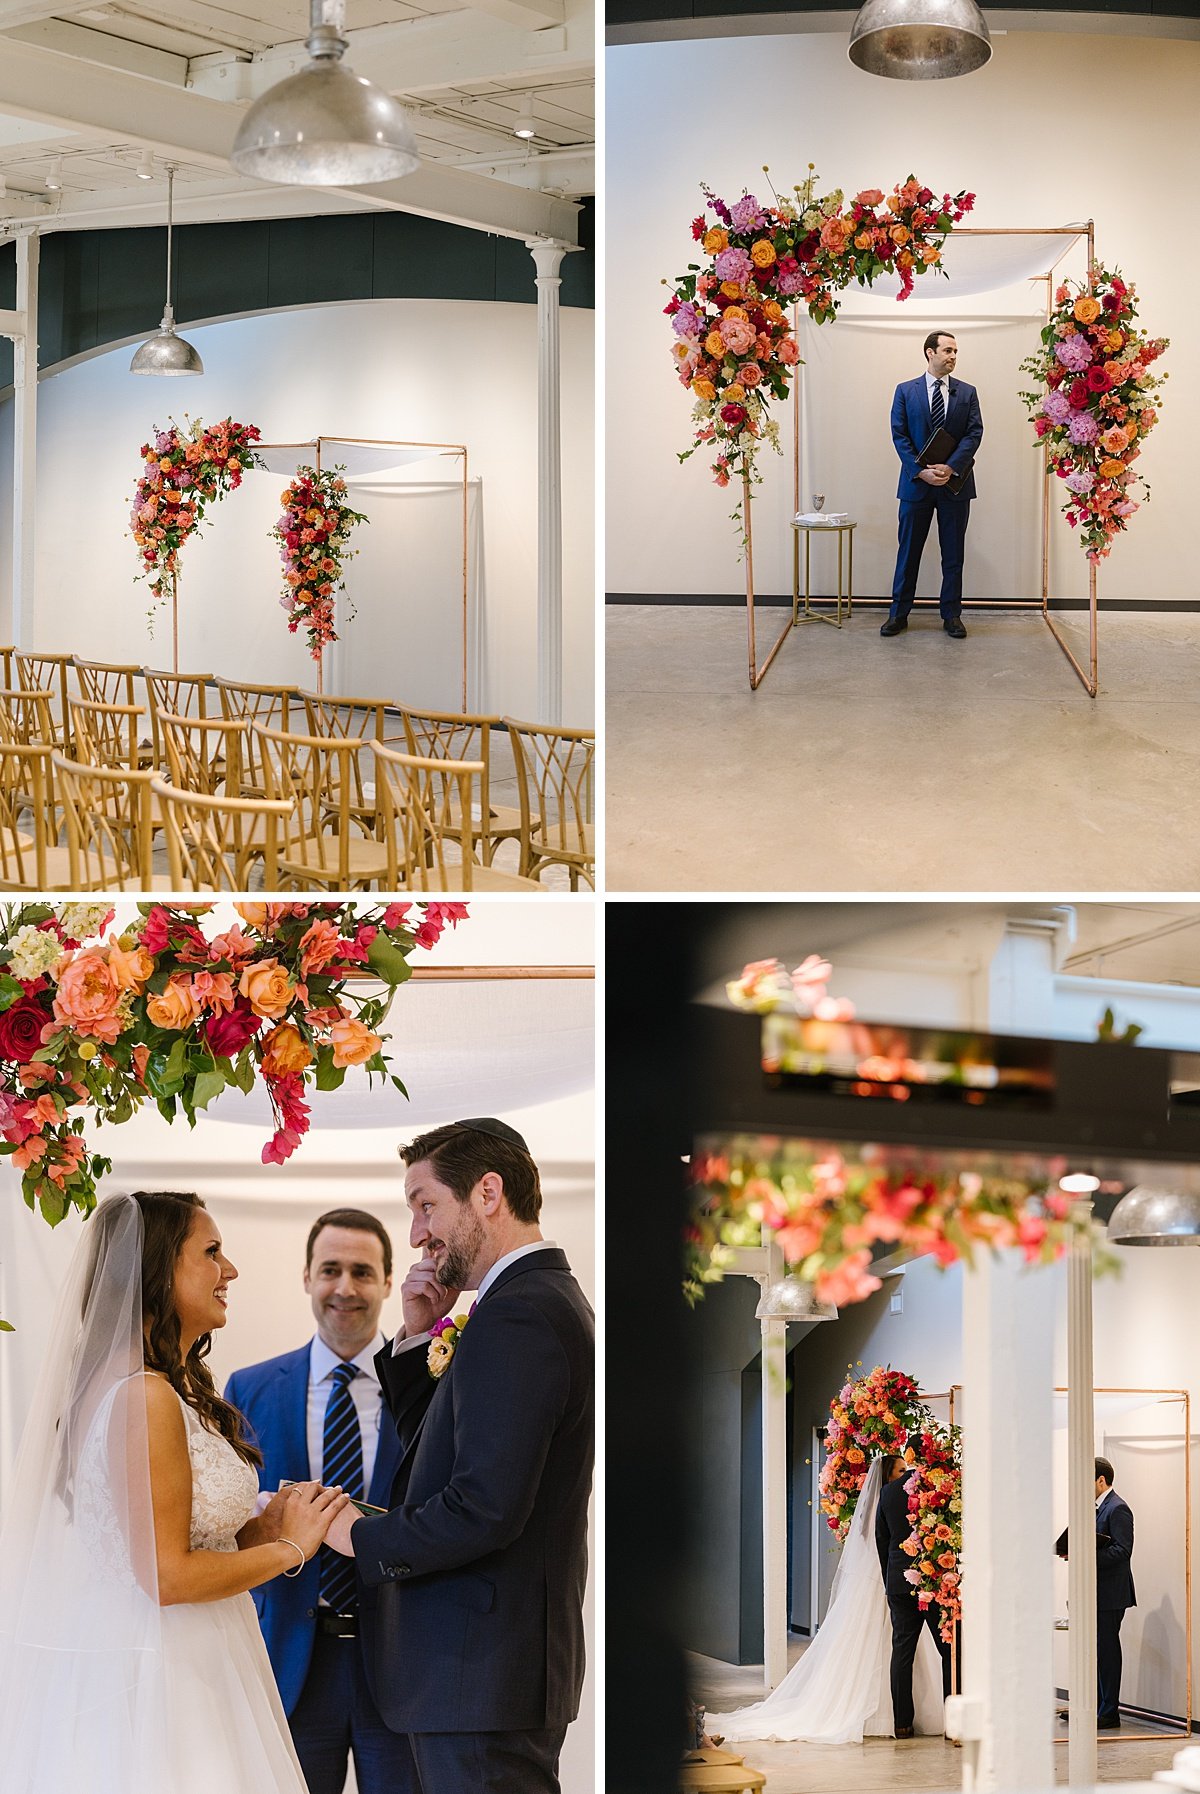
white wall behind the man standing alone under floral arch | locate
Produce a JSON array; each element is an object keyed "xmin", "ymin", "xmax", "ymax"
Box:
[{"xmin": 606, "ymin": 30, "xmax": 1200, "ymax": 601}]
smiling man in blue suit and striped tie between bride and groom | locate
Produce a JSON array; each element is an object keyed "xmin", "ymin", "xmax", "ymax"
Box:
[{"xmin": 226, "ymin": 1209, "xmax": 416, "ymax": 1794}]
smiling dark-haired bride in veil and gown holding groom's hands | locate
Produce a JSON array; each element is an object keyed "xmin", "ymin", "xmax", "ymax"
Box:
[{"xmin": 0, "ymin": 1193, "xmax": 348, "ymax": 1794}]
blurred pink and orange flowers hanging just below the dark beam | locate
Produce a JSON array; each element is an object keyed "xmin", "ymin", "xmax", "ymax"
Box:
[{"xmin": 683, "ymin": 1139, "xmax": 1116, "ymax": 1308}]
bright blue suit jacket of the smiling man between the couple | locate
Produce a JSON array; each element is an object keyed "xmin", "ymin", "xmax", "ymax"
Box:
[{"xmin": 224, "ymin": 1346, "xmax": 400, "ymax": 1713}]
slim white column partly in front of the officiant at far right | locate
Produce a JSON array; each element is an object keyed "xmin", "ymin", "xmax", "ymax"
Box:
[{"xmin": 1067, "ymin": 1202, "xmax": 1096, "ymax": 1787}]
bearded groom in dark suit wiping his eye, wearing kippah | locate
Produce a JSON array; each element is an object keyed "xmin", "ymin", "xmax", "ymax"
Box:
[{"xmin": 328, "ymin": 1116, "xmax": 596, "ymax": 1794}]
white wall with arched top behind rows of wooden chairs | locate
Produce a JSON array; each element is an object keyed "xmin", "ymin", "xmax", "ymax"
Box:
[{"xmin": 0, "ymin": 300, "xmax": 594, "ymax": 727}]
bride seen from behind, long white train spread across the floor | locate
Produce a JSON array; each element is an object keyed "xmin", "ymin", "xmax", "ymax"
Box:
[{"xmin": 705, "ymin": 1457, "xmax": 942, "ymax": 1744}]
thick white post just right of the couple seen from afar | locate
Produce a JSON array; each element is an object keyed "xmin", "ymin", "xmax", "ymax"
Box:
[{"xmin": 961, "ymin": 1252, "xmax": 1055, "ymax": 1794}]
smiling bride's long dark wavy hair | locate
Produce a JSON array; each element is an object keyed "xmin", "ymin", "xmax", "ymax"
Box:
[{"xmin": 133, "ymin": 1189, "xmax": 262, "ymax": 1467}]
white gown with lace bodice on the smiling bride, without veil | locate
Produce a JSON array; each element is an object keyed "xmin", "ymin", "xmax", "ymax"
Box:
[{"xmin": 79, "ymin": 1401, "xmax": 307, "ymax": 1794}]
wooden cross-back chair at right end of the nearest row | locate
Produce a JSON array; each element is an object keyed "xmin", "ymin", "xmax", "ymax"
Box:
[{"xmin": 371, "ymin": 741, "xmax": 543, "ymax": 892}]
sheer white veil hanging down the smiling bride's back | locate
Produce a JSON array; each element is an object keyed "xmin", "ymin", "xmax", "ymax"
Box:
[{"xmin": 0, "ymin": 1197, "xmax": 165, "ymax": 1794}]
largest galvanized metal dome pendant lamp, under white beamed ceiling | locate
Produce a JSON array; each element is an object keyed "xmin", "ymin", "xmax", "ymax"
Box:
[{"xmin": 230, "ymin": 0, "xmax": 420, "ymax": 187}]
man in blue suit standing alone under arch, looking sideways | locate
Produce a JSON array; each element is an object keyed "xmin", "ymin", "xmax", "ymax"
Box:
[{"xmin": 879, "ymin": 330, "xmax": 983, "ymax": 640}]
